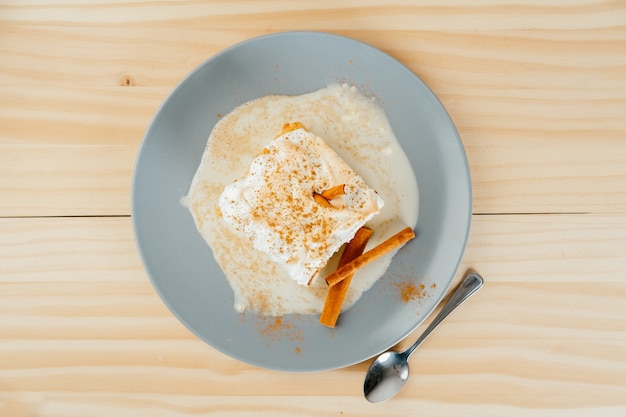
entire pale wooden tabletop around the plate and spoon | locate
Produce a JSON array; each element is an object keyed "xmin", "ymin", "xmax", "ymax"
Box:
[{"xmin": 0, "ymin": 0, "xmax": 626, "ymax": 417}]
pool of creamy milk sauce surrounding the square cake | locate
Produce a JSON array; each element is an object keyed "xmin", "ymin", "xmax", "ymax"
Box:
[{"xmin": 183, "ymin": 84, "xmax": 418, "ymax": 316}]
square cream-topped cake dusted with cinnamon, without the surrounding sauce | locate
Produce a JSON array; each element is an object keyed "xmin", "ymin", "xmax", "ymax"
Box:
[{"xmin": 219, "ymin": 122, "xmax": 384, "ymax": 285}]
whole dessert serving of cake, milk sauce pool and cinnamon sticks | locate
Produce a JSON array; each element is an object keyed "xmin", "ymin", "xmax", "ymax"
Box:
[{"xmin": 181, "ymin": 84, "xmax": 419, "ymax": 318}]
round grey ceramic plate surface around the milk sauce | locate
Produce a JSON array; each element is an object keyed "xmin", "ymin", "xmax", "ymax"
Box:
[{"xmin": 132, "ymin": 32, "xmax": 471, "ymax": 371}]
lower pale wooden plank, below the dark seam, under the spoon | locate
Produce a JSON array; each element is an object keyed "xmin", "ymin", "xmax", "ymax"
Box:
[{"xmin": 0, "ymin": 215, "xmax": 626, "ymax": 416}]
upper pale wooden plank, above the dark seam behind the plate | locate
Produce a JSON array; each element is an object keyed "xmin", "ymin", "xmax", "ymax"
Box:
[{"xmin": 0, "ymin": 0, "xmax": 626, "ymax": 216}]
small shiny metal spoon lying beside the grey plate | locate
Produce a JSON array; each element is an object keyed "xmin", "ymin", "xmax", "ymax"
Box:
[{"xmin": 363, "ymin": 272, "xmax": 483, "ymax": 403}]
